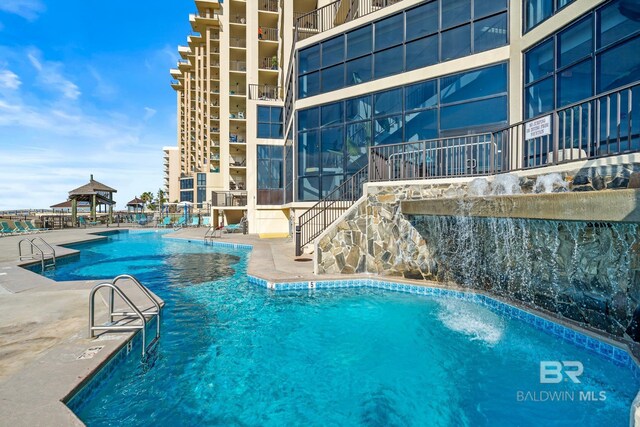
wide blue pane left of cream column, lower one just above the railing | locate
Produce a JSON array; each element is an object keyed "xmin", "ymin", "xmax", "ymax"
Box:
[{"xmin": 440, "ymin": 96, "xmax": 507, "ymax": 133}]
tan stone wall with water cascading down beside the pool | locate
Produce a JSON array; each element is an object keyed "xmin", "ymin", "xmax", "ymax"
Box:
[{"xmin": 315, "ymin": 167, "xmax": 640, "ymax": 342}]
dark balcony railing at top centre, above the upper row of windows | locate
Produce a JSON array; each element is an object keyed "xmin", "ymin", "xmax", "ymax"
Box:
[{"xmin": 293, "ymin": 0, "xmax": 402, "ymax": 40}]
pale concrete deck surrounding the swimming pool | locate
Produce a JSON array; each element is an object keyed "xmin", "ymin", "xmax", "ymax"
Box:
[{"xmin": 0, "ymin": 228, "xmax": 636, "ymax": 426}]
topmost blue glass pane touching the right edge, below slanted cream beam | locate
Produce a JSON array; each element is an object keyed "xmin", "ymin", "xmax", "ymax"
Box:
[{"xmin": 597, "ymin": 0, "xmax": 640, "ymax": 49}]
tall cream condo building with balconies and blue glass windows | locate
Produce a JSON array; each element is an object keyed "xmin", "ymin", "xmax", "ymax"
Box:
[{"xmin": 171, "ymin": 0, "xmax": 640, "ymax": 235}]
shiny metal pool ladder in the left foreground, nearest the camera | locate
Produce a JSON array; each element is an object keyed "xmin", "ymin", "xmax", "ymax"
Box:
[{"xmin": 89, "ymin": 274, "xmax": 161, "ymax": 360}]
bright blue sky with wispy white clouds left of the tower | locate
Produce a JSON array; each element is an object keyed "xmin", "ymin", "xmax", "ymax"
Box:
[{"xmin": 0, "ymin": 0, "xmax": 195, "ymax": 210}]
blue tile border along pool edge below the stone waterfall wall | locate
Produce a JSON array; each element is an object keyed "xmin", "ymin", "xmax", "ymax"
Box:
[{"xmin": 247, "ymin": 275, "xmax": 640, "ymax": 372}]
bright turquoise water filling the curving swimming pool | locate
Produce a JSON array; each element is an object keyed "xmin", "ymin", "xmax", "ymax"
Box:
[{"xmin": 47, "ymin": 232, "xmax": 640, "ymax": 426}]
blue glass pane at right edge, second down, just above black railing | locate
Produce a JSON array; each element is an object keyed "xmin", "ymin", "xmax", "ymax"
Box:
[{"xmin": 597, "ymin": 36, "xmax": 640, "ymax": 93}]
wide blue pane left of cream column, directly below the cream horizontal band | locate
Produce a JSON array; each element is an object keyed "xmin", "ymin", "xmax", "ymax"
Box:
[{"xmin": 440, "ymin": 63, "xmax": 507, "ymax": 104}]
